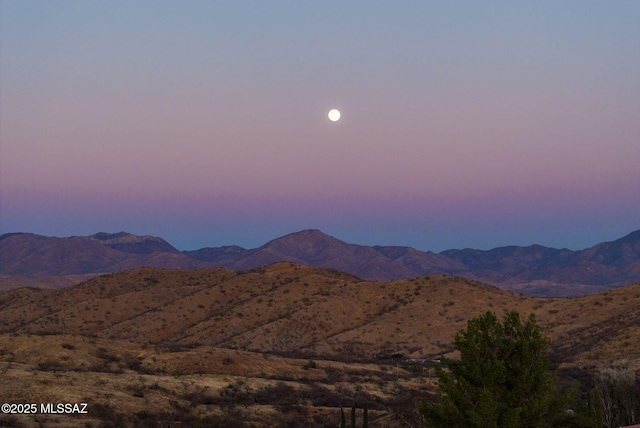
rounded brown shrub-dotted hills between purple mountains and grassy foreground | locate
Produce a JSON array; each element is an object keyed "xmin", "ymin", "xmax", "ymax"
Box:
[{"xmin": 0, "ymin": 263, "xmax": 640, "ymax": 363}]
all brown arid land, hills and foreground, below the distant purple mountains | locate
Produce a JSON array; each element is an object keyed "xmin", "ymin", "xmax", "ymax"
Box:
[{"xmin": 0, "ymin": 262, "xmax": 640, "ymax": 427}]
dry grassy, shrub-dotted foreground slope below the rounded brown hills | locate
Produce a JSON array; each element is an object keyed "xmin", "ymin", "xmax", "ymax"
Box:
[{"xmin": 0, "ymin": 334, "xmax": 434, "ymax": 427}]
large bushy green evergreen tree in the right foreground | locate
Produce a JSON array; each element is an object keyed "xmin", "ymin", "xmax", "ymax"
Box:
[{"xmin": 420, "ymin": 311, "xmax": 571, "ymax": 428}]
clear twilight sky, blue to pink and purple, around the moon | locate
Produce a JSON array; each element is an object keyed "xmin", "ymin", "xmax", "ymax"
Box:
[{"xmin": 0, "ymin": 0, "xmax": 640, "ymax": 251}]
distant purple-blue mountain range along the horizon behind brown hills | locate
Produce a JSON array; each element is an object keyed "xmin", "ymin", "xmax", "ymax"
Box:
[{"xmin": 0, "ymin": 230, "xmax": 640, "ymax": 296}]
